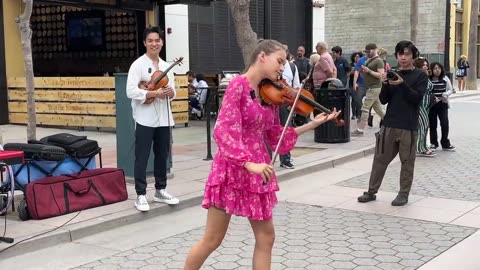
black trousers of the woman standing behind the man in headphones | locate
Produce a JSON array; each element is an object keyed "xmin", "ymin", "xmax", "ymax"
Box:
[{"xmin": 428, "ymin": 102, "xmax": 450, "ymax": 147}]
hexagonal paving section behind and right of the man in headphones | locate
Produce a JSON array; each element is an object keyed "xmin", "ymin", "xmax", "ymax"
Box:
[{"xmin": 337, "ymin": 137, "xmax": 480, "ymax": 201}]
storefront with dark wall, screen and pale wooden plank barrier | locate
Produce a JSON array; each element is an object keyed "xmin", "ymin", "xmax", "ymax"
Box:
[{"xmin": 0, "ymin": 0, "xmax": 156, "ymax": 128}]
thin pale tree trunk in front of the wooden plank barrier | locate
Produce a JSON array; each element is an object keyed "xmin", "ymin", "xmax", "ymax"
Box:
[{"xmin": 15, "ymin": 0, "xmax": 37, "ymax": 140}]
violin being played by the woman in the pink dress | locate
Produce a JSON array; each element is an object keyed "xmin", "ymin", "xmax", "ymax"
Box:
[{"xmin": 259, "ymin": 79, "xmax": 345, "ymax": 126}]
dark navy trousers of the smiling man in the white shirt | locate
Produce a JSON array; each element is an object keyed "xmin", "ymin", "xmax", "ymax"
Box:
[{"xmin": 133, "ymin": 123, "xmax": 170, "ymax": 195}]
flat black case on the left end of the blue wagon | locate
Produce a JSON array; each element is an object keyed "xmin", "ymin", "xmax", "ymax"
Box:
[{"xmin": 3, "ymin": 143, "xmax": 67, "ymax": 161}]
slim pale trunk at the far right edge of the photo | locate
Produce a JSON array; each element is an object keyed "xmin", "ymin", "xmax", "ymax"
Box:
[{"xmin": 465, "ymin": 0, "xmax": 479, "ymax": 90}]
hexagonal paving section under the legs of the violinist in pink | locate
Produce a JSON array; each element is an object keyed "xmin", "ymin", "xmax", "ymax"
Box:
[{"xmin": 74, "ymin": 203, "xmax": 476, "ymax": 270}]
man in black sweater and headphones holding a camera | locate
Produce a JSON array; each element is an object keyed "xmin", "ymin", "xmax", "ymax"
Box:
[{"xmin": 358, "ymin": 40, "xmax": 428, "ymax": 206}]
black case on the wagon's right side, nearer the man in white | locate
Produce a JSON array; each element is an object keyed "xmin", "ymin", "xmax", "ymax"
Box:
[{"xmin": 40, "ymin": 133, "xmax": 101, "ymax": 158}]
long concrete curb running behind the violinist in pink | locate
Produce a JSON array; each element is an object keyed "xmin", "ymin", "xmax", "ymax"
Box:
[{"xmin": 0, "ymin": 144, "xmax": 375, "ymax": 260}]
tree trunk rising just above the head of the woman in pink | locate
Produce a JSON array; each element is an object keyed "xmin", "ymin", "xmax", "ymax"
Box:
[{"xmin": 227, "ymin": 0, "xmax": 257, "ymax": 66}]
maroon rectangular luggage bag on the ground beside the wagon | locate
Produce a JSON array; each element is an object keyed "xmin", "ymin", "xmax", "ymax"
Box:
[{"xmin": 25, "ymin": 168, "xmax": 128, "ymax": 219}]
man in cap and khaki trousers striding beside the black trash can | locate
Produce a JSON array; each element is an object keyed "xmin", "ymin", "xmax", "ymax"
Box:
[{"xmin": 351, "ymin": 43, "xmax": 385, "ymax": 136}]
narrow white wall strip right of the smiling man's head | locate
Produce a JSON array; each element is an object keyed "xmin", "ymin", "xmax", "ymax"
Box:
[{"xmin": 165, "ymin": 5, "xmax": 190, "ymax": 74}]
